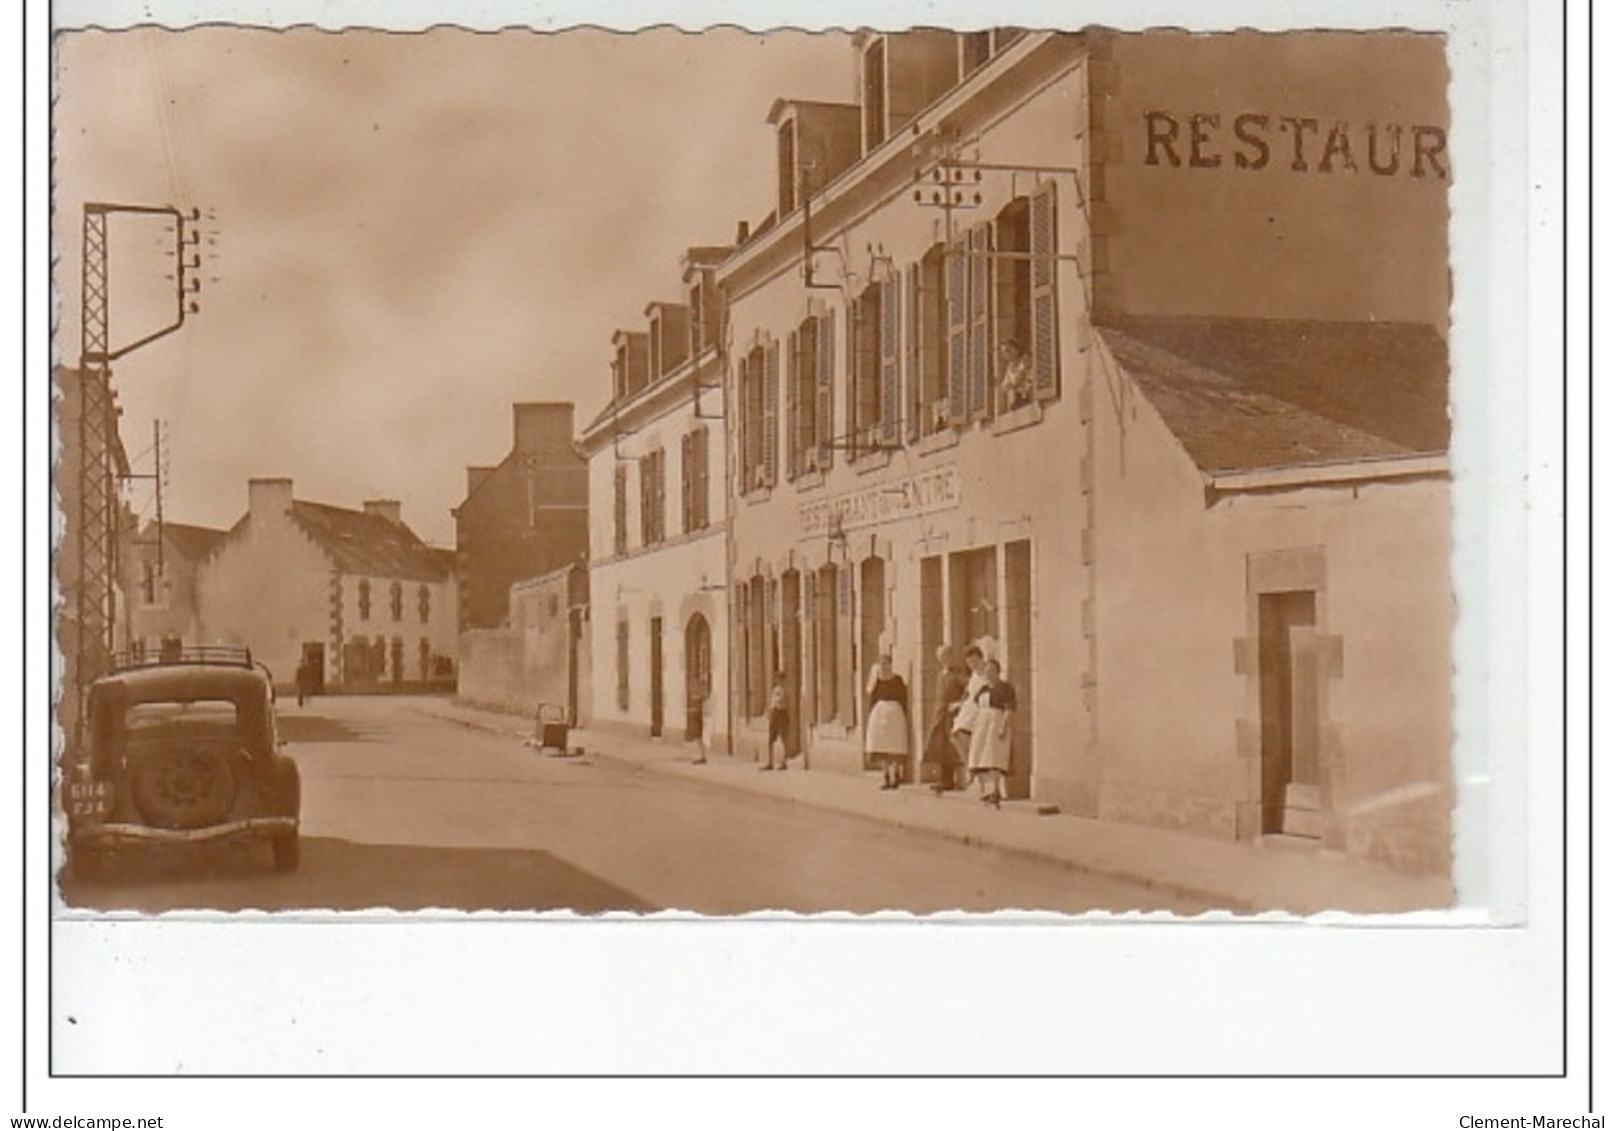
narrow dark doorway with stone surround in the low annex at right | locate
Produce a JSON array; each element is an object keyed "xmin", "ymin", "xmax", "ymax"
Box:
[{"xmin": 1258, "ymin": 590, "xmax": 1321, "ymax": 837}]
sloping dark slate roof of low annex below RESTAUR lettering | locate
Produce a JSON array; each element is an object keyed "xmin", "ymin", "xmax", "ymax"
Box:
[{"xmin": 1098, "ymin": 315, "xmax": 1450, "ymax": 472}]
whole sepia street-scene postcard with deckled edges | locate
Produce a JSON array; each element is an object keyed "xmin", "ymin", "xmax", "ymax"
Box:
[{"xmin": 28, "ymin": 5, "xmax": 1563, "ymax": 1098}]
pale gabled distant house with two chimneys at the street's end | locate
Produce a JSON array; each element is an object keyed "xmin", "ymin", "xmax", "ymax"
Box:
[{"xmin": 197, "ymin": 478, "xmax": 459, "ymax": 690}]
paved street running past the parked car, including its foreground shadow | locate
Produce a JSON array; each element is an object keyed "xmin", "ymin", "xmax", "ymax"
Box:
[{"xmin": 61, "ymin": 696, "xmax": 1205, "ymax": 914}]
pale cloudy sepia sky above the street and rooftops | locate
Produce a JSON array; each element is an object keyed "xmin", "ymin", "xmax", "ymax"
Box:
[{"xmin": 53, "ymin": 26, "xmax": 854, "ymax": 544}]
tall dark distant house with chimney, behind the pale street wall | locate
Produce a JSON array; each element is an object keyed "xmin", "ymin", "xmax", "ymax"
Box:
[{"xmin": 454, "ymin": 402, "xmax": 589, "ymax": 629}]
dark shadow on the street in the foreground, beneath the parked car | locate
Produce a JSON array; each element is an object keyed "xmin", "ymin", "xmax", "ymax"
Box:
[{"xmin": 60, "ymin": 837, "xmax": 656, "ymax": 914}]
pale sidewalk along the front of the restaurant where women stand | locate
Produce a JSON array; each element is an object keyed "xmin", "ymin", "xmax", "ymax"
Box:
[{"xmin": 417, "ymin": 700, "xmax": 1452, "ymax": 914}]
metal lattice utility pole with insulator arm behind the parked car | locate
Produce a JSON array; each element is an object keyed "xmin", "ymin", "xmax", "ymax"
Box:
[{"xmin": 69, "ymin": 202, "xmax": 202, "ymax": 740}]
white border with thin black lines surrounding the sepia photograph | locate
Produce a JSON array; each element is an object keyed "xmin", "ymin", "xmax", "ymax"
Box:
[{"xmin": 6, "ymin": 0, "xmax": 1586, "ymax": 1126}]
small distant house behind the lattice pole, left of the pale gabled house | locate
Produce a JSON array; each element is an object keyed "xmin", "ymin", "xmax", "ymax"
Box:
[{"xmin": 123, "ymin": 522, "xmax": 228, "ymax": 651}]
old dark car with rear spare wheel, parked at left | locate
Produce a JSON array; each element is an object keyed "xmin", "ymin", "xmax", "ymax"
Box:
[{"xmin": 61, "ymin": 648, "xmax": 302, "ymax": 877}]
